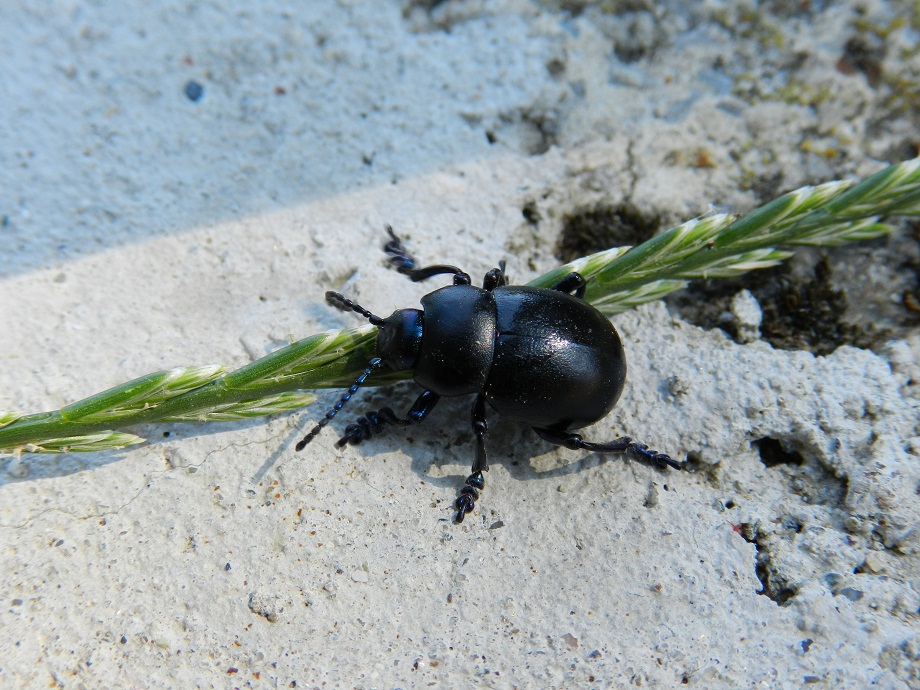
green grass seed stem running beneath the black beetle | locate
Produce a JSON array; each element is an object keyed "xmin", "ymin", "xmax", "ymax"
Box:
[{"xmin": 0, "ymin": 159, "xmax": 920, "ymax": 454}]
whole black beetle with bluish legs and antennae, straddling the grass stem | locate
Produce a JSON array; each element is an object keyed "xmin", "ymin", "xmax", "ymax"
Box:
[{"xmin": 296, "ymin": 226, "xmax": 682, "ymax": 522}]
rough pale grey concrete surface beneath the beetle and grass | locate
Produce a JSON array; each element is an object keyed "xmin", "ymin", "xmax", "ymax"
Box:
[{"xmin": 0, "ymin": 0, "xmax": 920, "ymax": 688}]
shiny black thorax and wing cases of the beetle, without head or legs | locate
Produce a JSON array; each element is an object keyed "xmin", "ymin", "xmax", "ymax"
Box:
[{"xmin": 413, "ymin": 285, "xmax": 626, "ymax": 431}]
